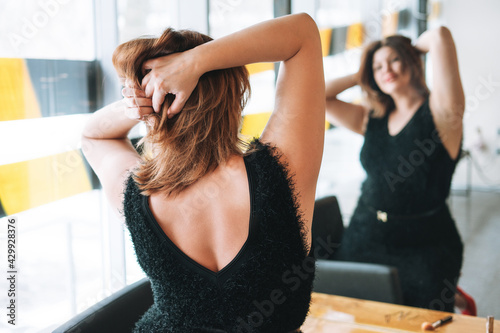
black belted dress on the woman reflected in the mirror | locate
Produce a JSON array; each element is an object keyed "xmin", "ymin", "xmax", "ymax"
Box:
[{"xmin": 335, "ymin": 99, "xmax": 463, "ymax": 312}]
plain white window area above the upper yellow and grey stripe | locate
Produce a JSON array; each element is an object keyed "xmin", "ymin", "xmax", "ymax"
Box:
[{"xmin": 0, "ymin": 0, "xmax": 95, "ymax": 60}]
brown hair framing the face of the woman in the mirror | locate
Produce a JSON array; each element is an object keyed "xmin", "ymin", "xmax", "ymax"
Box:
[{"xmin": 360, "ymin": 35, "xmax": 429, "ymax": 117}]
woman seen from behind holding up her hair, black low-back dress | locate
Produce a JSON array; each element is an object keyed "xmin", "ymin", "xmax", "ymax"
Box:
[{"xmin": 83, "ymin": 14, "xmax": 325, "ymax": 332}]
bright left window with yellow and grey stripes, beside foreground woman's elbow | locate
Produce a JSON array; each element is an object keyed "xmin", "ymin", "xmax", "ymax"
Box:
[{"xmin": 0, "ymin": 0, "xmax": 102, "ymax": 329}]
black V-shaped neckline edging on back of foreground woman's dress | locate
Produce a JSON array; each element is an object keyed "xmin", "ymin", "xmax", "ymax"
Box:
[{"xmin": 142, "ymin": 157, "xmax": 256, "ymax": 283}]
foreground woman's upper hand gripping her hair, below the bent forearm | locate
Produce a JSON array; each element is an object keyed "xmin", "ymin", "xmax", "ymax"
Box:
[{"xmin": 142, "ymin": 51, "xmax": 203, "ymax": 118}]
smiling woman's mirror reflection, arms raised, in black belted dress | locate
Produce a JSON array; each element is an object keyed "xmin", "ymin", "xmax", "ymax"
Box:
[{"xmin": 326, "ymin": 27, "xmax": 465, "ymax": 312}]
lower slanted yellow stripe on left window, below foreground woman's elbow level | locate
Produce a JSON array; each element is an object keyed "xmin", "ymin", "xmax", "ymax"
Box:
[{"xmin": 0, "ymin": 150, "xmax": 92, "ymax": 215}]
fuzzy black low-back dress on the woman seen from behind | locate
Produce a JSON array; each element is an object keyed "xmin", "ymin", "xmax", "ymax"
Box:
[{"xmin": 124, "ymin": 141, "xmax": 315, "ymax": 333}]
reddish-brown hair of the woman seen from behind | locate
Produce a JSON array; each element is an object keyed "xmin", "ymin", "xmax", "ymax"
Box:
[{"xmin": 113, "ymin": 28, "xmax": 250, "ymax": 195}]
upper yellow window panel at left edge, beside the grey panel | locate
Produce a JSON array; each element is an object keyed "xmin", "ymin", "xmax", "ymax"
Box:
[{"xmin": 0, "ymin": 58, "xmax": 41, "ymax": 121}]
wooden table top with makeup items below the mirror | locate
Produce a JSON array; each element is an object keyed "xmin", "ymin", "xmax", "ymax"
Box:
[{"xmin": 301, "ymin": 293, "xmax": 500, "ymax": 333}]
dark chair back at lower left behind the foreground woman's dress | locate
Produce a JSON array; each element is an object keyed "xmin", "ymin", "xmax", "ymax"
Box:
[{"xmin": 53, "ymin": 278, "xmax": 153, "ymax": 333}]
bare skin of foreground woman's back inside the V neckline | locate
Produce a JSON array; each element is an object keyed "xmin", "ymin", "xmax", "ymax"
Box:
[{"xmin": 149, "ymin": 156, "xmax": 250, "ymax": 272}]
